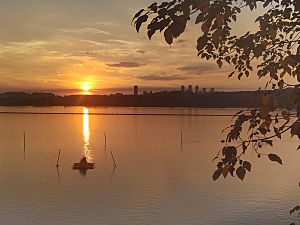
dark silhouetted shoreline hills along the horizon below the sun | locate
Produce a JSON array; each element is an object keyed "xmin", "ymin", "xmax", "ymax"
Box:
[{"xmin": 0, "ymin": 90, "xmax": 292, "ymax": 108}]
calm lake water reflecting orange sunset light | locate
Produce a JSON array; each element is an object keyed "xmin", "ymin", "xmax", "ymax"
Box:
[{"xmin": 0, "ymin": 107, "xmax": 300, "ymax": 225}]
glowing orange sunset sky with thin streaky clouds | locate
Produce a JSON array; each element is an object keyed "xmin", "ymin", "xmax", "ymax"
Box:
[{"xmin": 0, "ymin": 0, "xmax": 272, "ymax": 93}]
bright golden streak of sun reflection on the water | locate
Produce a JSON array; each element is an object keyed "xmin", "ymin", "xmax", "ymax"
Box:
[{"xmin": 83, "ymin": 107, "xmax": 93, "ymax": 162}]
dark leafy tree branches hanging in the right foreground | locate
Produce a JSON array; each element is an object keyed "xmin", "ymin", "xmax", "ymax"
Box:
[{"xmin": 132, "ymin": 0, "xmax": 300, "ymax": 221}]
